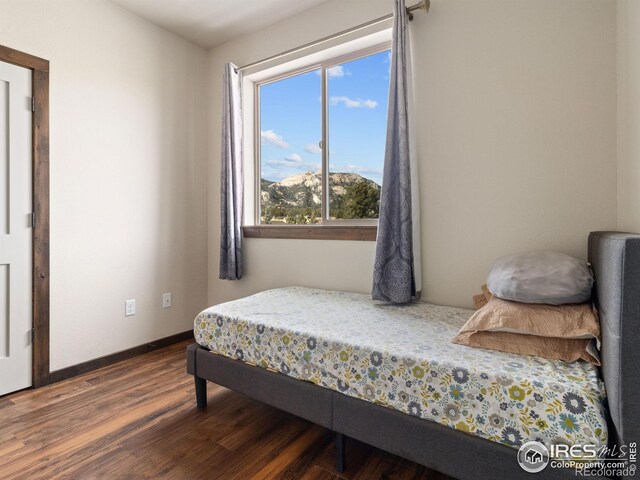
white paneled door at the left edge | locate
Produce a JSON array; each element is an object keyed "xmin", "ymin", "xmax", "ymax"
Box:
[{"xmin": 0, "ymin": 62, "xmax": 33, "ymax": 395}]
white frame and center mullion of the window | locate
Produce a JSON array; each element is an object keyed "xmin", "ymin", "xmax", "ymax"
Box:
[{"xmin": 253, "ymin": 41, "xmax": 391, "ymax": 227}]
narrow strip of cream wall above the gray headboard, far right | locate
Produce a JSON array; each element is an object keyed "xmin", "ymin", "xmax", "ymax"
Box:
[{"xmin": 617, "ymin": 0, "xmax": 640, "ymax": 232}]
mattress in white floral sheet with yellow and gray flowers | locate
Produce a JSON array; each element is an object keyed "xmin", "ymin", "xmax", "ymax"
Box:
[{"xmin": 194, "ymin": 287, "xmax": 607, "ymax": 448}]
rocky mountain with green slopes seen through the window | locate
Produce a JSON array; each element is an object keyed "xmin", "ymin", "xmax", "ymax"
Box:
[{"xmin": 261, "ymin": 172, "xmax": 380, "ymax": 208}]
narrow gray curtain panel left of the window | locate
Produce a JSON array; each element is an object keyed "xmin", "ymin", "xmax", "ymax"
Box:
[{"xmin": 220, "ymin": 63, "xmax": 242, "ymax": 280}]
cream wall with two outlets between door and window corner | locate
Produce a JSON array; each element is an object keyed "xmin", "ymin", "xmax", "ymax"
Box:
[{"xmin": 0, "ymin": 0, "xmax": 207, "ymax": 370}]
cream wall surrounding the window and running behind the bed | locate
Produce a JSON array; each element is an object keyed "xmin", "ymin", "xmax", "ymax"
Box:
[{"xmin": 208, "ymin": 0, "xmax": 617, "ymax": 306}]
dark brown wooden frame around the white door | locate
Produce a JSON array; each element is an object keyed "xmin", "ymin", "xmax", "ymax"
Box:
[{"xmin": 0, "ymin": 45, "xmax": 50, "ymax": 388}]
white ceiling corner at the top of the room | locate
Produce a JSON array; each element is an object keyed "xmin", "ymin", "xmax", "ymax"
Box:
[{"xmin": 111, "ymin": 0, "xmax": 326, "ymax": 49}]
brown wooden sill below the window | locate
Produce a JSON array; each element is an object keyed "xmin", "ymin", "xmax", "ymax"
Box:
[{"xmin": 242, "ymin": 225, "xmax": 378, "ymax": 242}]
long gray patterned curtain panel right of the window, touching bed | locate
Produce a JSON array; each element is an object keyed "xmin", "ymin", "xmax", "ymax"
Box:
[{"xmin": 372, "ymin": 0, "xmax": 416, "ymax": 303}]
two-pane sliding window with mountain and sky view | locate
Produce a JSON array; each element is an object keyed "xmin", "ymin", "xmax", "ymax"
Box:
[{"xmin": 256, "ymin": 45, "xmax": 390, "ymax": 225}]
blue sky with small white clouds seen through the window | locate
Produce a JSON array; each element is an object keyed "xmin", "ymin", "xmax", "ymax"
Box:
[{"xmin": 260, "ymin": 51, "xmax": 389, "ymax": 184}]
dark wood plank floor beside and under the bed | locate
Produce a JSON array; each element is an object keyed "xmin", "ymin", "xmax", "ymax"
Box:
[{"xmin": 0, "ymin": 342, "xmax": 456, "ymax": 480}]
